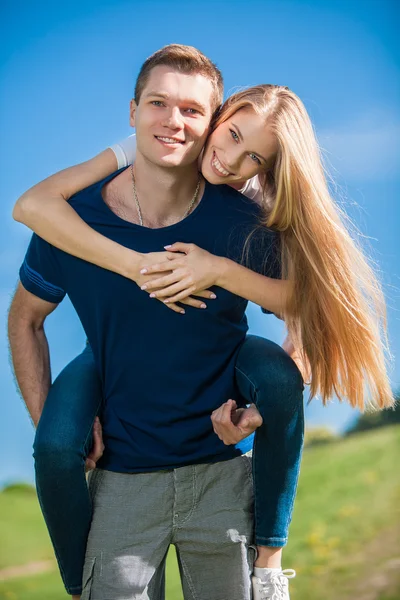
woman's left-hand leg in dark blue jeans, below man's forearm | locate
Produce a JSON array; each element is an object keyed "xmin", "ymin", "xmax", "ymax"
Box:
[{"xmin": 34, "ymin": 346, "xmax": 102, "ymax": 596}]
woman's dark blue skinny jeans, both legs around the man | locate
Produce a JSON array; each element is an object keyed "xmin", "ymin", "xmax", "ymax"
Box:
[{"xmin": 34, "ymin": 336, "xmax": 304, "ymax": 594}]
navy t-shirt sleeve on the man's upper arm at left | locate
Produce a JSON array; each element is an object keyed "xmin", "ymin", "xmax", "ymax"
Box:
[{"xmin": 19, "ymin": 234, "xmax": 66, "ymax": 304}]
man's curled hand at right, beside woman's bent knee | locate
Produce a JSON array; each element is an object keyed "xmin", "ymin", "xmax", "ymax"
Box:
[{"xmin": 211, "ymin": 400, "xmax": 263, "ymax": 446}]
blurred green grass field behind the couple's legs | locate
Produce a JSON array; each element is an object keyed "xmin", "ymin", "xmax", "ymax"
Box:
[{"xmin": 0, "ymin": 426, "xmax": 400, "ymax": 600}]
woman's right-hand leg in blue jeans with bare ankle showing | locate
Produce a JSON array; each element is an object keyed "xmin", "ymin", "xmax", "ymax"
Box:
[{"xmin": 236, "ymin": 335, "xmax": 304, "ymax": 567}]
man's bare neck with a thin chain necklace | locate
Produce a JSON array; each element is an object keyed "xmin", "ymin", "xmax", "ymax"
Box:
[{"xmin": 125, "ymin": 154, "xmax": 203, "ymax": 227}]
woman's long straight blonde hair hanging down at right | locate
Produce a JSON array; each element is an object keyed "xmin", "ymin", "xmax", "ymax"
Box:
[{"xmin": 214, "ymin": 85, "xmax": 393, "ymax": 409}]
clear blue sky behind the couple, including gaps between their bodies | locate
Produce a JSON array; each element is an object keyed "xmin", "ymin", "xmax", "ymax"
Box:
[{"xmin": 0, "ymin": 0, "xmax": 400, "ymax": 483}]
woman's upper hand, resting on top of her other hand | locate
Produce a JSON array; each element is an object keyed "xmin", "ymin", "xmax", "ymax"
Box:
[{"xmin": 140, "ymin": 242, "xmax": 222, "ymax": 305}]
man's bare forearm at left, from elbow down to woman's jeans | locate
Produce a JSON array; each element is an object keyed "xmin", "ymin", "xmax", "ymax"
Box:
[{"xmin": 8, "ymin": 315, "xmax": 51, "ymax": 427}]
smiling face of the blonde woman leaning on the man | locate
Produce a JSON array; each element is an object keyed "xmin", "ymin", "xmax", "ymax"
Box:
[{"xmin": 201, "ymin": 108, "xmax": 278, "ymax": 188}]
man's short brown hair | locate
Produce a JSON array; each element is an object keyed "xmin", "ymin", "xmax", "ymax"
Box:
[{"xmin": 135, "ymin": 44, "xmax": 224, "ymax": 113}]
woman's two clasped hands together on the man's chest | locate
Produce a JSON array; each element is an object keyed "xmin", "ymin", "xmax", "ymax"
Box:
[{"xmin": 135, "ymin": 242, "xmax": 221, "ymax": 314}]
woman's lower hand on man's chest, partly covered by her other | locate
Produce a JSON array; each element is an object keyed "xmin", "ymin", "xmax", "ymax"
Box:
[{"xmin": 132, "ymin": 252, "xmax": 215, "ymax": 314}]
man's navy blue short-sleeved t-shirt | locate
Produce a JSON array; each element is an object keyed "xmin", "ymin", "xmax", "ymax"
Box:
[{"xmin": 20, "ymin": 172, "xmax": 279, "ymax": 472}]
